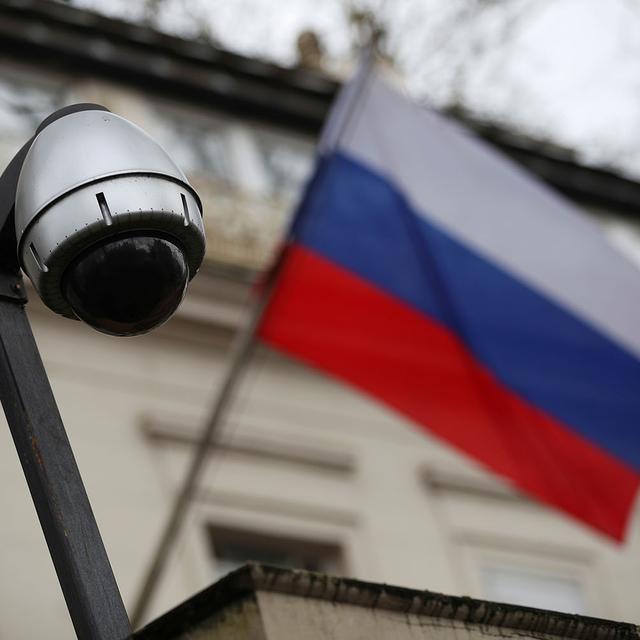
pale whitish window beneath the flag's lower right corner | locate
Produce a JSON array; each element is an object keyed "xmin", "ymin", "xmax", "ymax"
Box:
[{"xmin": 481, "ymin": 566, "xmax": 587, "ymax": 614}]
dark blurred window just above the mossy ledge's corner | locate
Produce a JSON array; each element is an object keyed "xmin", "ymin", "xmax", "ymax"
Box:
[{"xmin": 209, "ymin": 527, "xmax": 343, "ymax": 578}]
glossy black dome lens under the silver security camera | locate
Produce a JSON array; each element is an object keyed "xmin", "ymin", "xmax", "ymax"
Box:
[{"xmin": 62, "ymin": 236, "xmax": 189, "ymax": 336}]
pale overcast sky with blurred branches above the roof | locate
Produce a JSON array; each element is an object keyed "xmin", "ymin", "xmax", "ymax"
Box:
[{"xmin": 74, "ymin": 0, "xmax": 640, "ymax": 177}]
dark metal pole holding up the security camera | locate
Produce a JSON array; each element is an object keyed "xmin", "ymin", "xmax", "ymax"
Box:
[{"xmin": 0, "ymin": 224, "xmax": 131, "ymax": 640}]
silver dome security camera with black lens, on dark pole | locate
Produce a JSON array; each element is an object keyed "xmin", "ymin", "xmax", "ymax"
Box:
[{"xmin": 1, "ymin": 105, "xmax": 205, "ymax": 336}]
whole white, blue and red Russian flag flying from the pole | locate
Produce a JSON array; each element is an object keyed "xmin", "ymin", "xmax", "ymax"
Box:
[{"xmin": 259, "ymin": 61, "xmax": 640, "ymax": 540}]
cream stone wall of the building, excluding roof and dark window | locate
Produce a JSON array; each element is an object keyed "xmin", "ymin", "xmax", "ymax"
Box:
[{"xmin": 0, "ymin": 61, "xmax": 640, "ymax": 640}]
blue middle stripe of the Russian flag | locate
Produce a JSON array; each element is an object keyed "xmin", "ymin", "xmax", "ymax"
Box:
[{"xmin": 294, "ymin": 153, "xmax": 640, "ymax": 471}]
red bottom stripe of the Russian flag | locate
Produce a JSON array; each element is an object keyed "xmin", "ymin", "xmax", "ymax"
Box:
[{"xmin": 260, "ymin": 246, "xmax": 639, "ymax": 540}]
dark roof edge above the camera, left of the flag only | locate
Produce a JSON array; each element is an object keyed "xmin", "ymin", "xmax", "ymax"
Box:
[{"xmin": 0, "ymin": 0, "xmax": 337, "ymax": 133}]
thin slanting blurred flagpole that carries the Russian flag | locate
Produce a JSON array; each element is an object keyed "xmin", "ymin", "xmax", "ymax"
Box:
[{"xmin": 131, "ymin": 45, "xmax": 375, "ymax": 629}]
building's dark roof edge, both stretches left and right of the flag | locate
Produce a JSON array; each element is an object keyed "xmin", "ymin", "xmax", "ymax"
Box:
[{"xmin": 0, "ymin": 0, "xmax": 640, "ymax": 217}]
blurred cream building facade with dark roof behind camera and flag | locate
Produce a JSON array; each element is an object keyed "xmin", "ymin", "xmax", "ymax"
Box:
[{"xmin": 0, "ymin": 0, "xmax": 640, "ymax": 640}]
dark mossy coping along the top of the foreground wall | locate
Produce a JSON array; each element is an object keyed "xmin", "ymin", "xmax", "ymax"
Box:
[{"xmin": 134, "ymin": 564, "xmax": 640, "ymax": 640}]
